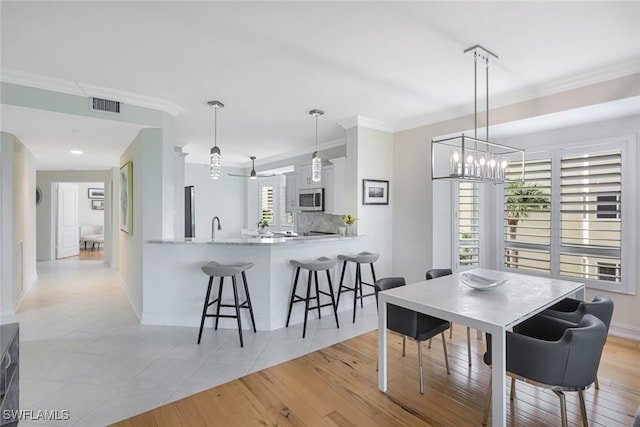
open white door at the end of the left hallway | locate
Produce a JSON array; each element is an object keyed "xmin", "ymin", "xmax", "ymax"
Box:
[{"xmin": 56, "ymin": 183, "xmax": 80, "ymax": 258}]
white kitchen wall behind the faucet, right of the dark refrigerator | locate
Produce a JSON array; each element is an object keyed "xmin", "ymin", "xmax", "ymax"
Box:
[{"xmin": 185, "ymin": 163, "xmax": 248, "ymax": 239}]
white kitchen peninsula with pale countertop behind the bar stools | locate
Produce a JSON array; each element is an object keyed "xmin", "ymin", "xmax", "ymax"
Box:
[{"xmin": 141, "ymin": 235, "xmax": 373, "ymax": 332}]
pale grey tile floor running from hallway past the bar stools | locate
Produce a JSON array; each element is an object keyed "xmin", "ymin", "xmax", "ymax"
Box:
[{"xmin": 2, "ymin": 260, "xmax": 377, "ymax": 427}]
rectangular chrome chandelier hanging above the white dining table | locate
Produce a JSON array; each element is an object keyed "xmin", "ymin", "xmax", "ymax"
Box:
[{"xmin": 431, "ymin": 45, "xmax": 524, "ymax": 184}]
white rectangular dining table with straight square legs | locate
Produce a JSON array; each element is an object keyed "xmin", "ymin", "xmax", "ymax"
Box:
[{"xmin": 378, "ymin": 268, "xmax": 584, "ymax": 426}]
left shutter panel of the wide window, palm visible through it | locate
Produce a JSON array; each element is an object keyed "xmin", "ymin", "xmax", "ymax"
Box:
[{"xmin": 503, "ymin": 158, "xmax": 551, "ymax": 274}]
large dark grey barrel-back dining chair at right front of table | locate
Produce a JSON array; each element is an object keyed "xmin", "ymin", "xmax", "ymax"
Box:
[{"xmin": 482, "ymin": 314, "xmax": 607, "ymax": 427}]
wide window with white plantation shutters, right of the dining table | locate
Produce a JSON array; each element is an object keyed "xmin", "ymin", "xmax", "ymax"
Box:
[{"xmin": 503, "ymin": 137, "xmax": 636, "ymax": 293}]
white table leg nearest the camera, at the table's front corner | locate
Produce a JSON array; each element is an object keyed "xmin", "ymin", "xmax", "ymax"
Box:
[{"xmin": 491, "ymin": 330, "xmax": 507, "ymax": 426}]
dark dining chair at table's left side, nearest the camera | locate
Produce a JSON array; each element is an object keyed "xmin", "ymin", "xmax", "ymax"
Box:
[{"xmin": 374, "ymin": 277, "xmax": 450, "ymax": 394}]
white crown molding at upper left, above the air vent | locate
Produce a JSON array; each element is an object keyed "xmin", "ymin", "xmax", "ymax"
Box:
[{"xmin": 0, "ymin": 68, "xmax": 185, "ymax": 116}]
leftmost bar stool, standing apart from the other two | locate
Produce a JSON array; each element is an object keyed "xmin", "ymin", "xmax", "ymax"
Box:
[{"xmin": 198, "ymin": 261, "xmax": 256, "ymax": 347}]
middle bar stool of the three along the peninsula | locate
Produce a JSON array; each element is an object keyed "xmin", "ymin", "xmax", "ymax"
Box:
[{"xmin": 286, "ymin": 257, "xmax": 340, "ymax": 338}]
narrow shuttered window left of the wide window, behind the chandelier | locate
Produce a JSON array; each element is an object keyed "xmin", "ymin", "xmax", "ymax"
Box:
[{"xmin": 457, "ymin": 182, "xmax": 480, "ymax": 269}]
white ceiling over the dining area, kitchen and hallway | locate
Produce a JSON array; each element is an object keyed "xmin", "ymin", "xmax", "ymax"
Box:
[{"xmin": 0, "ymin": 1, "xmax": 640, "ymax": 169}]
